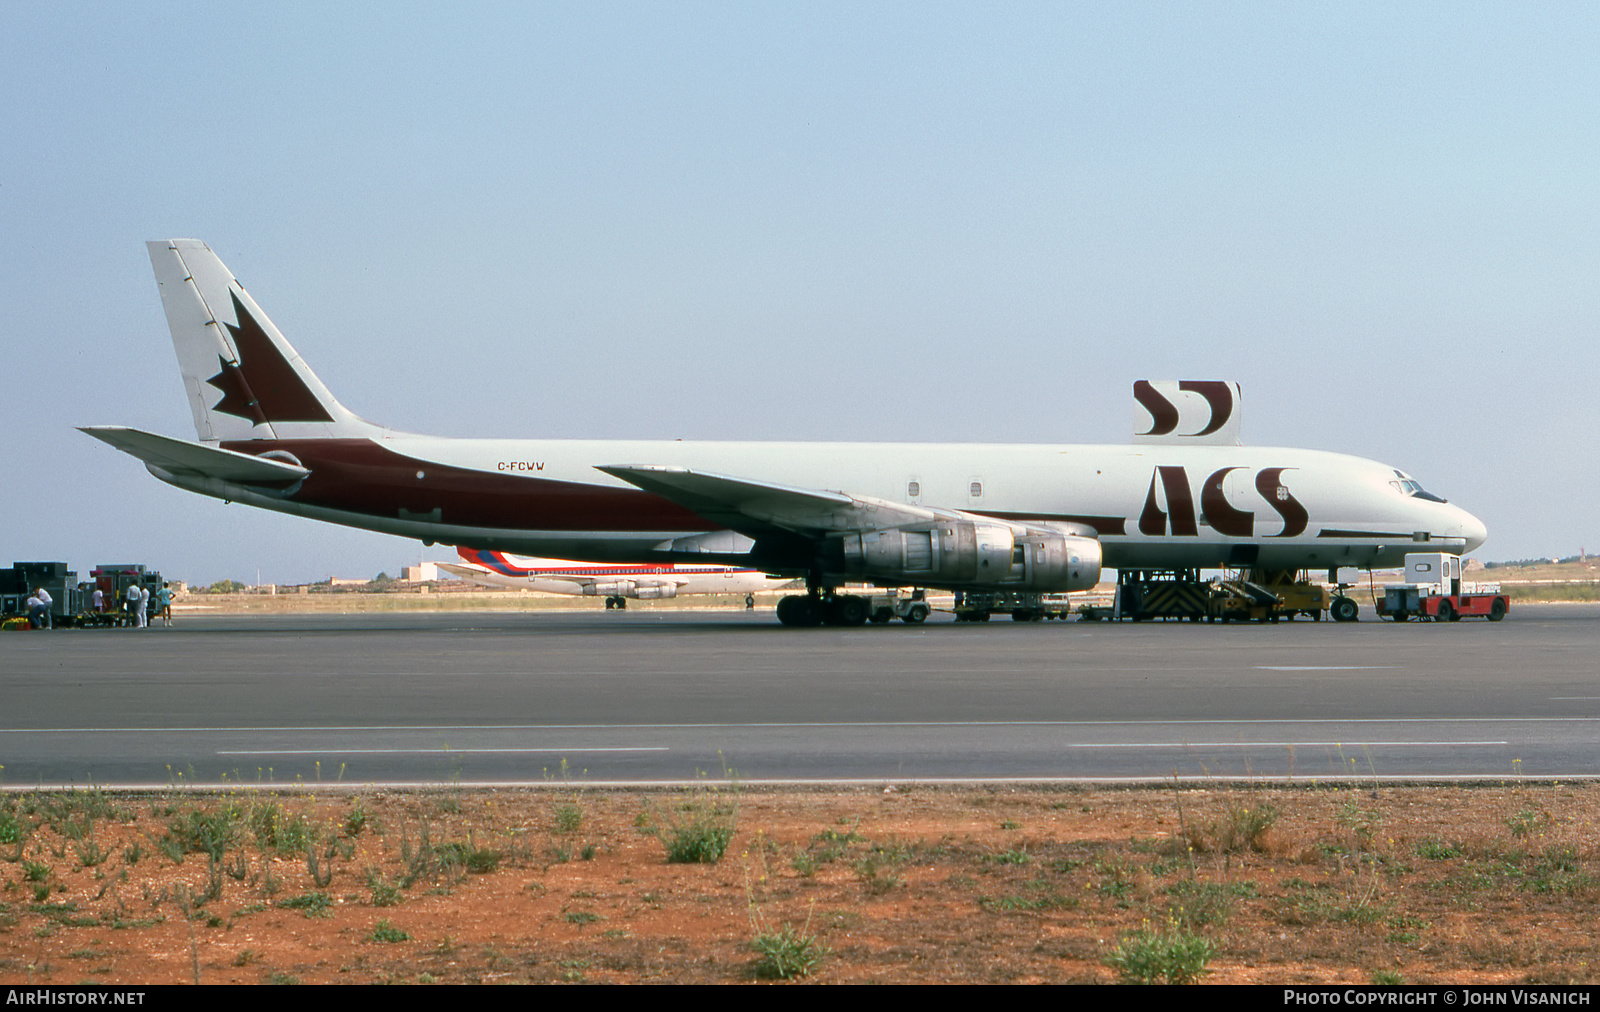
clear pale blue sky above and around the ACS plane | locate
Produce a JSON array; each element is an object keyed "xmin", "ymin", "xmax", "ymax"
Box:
[{"xmin": 0, "ymin": 2, "xmax": 1600, "ymax": 583}]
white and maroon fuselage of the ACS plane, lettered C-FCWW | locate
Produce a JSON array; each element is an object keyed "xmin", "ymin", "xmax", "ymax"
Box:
[{"xmin": 152, "ymin": 434, "xmax": 1485, "ymax": 568}]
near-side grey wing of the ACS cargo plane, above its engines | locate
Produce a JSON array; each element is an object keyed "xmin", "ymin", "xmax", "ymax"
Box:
[{"xmin": 597, "ymin": 464, "xmax": 934, "ymax": 538}]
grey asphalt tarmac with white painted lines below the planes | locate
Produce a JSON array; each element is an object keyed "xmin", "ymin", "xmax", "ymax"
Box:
[{"xmin": 0, "ymin": 605, "xmax": 1600, "ymax": 788}]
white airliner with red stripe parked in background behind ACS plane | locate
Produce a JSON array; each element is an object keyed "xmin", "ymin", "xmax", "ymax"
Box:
[{"xmin": 438, "ymin": 548, "xmax": 794, "ymax": 608}]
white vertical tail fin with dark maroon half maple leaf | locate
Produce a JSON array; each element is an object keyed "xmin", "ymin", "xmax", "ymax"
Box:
[{"xmin": 146, "ymin": 239, "xmax": 382, "ymax": 442}]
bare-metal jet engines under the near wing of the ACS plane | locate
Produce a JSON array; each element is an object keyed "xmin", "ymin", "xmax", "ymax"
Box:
[{"xmin": 827, "ymin": 520, "xmax": 1101, "ymax": 594}]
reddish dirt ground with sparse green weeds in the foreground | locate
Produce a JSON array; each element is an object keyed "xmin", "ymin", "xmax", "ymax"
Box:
[{"xmin": 0, "ymin": 785, "xmax": 1600, "ymax": 985}]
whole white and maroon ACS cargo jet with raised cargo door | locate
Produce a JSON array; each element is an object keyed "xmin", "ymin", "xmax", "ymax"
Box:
[{"xmin": 85, "ymin": 239, "xmax": 1485, "ymax": 624}]
